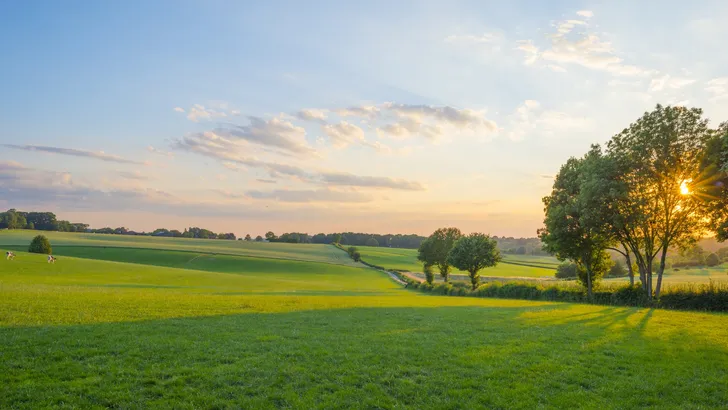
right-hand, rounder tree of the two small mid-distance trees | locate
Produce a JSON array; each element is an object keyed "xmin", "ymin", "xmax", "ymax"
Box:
[{"xmin": 447, "ymin": 233, "xmax": 501, "ymax": 290}]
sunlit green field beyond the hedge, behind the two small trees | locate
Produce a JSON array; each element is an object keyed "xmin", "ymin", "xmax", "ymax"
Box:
[{"xmin": 357, "ymin": 246, "xmax": 558, "ymax": 278}]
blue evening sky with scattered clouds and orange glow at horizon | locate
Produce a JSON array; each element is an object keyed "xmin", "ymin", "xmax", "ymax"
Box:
[{"xmin": 0, "ymin": 0, "xmax": 728, "ymax": 237}]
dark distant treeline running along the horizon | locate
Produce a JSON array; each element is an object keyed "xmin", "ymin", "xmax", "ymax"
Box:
[{"xmin": 0, "ymin": 209, "xmax": 546, "ymax": 251}]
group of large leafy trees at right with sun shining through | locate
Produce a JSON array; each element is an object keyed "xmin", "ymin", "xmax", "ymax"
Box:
[{"xmin": 538, "ymin": 105, "xmax": 728, "ymax": 300}]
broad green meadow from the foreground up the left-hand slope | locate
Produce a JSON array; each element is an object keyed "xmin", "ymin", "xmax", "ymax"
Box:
[{"xmin": 0, "ymin": 232, "xmax": 728, "ymax": 409}]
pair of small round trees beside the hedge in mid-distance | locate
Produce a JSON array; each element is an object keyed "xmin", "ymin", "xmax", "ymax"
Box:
[{"xmin": 417, "ymin": 228, "xmax": 501, "ymax": 290}]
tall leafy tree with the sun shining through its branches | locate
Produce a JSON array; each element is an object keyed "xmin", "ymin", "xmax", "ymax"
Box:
[{"xmin": 600, "ymin": 105, "xmax": 720, "ymax": 298}]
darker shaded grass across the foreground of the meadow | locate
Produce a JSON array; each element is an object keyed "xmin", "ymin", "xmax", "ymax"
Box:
[{"xmin": 0, "ymin": 304, "xmax": 728, "ymax": 408}]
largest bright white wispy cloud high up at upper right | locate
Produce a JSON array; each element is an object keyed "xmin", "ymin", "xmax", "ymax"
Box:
[{"xmin": 516, "ymin": 14, "xmax": 656, "ymax": 76}]
